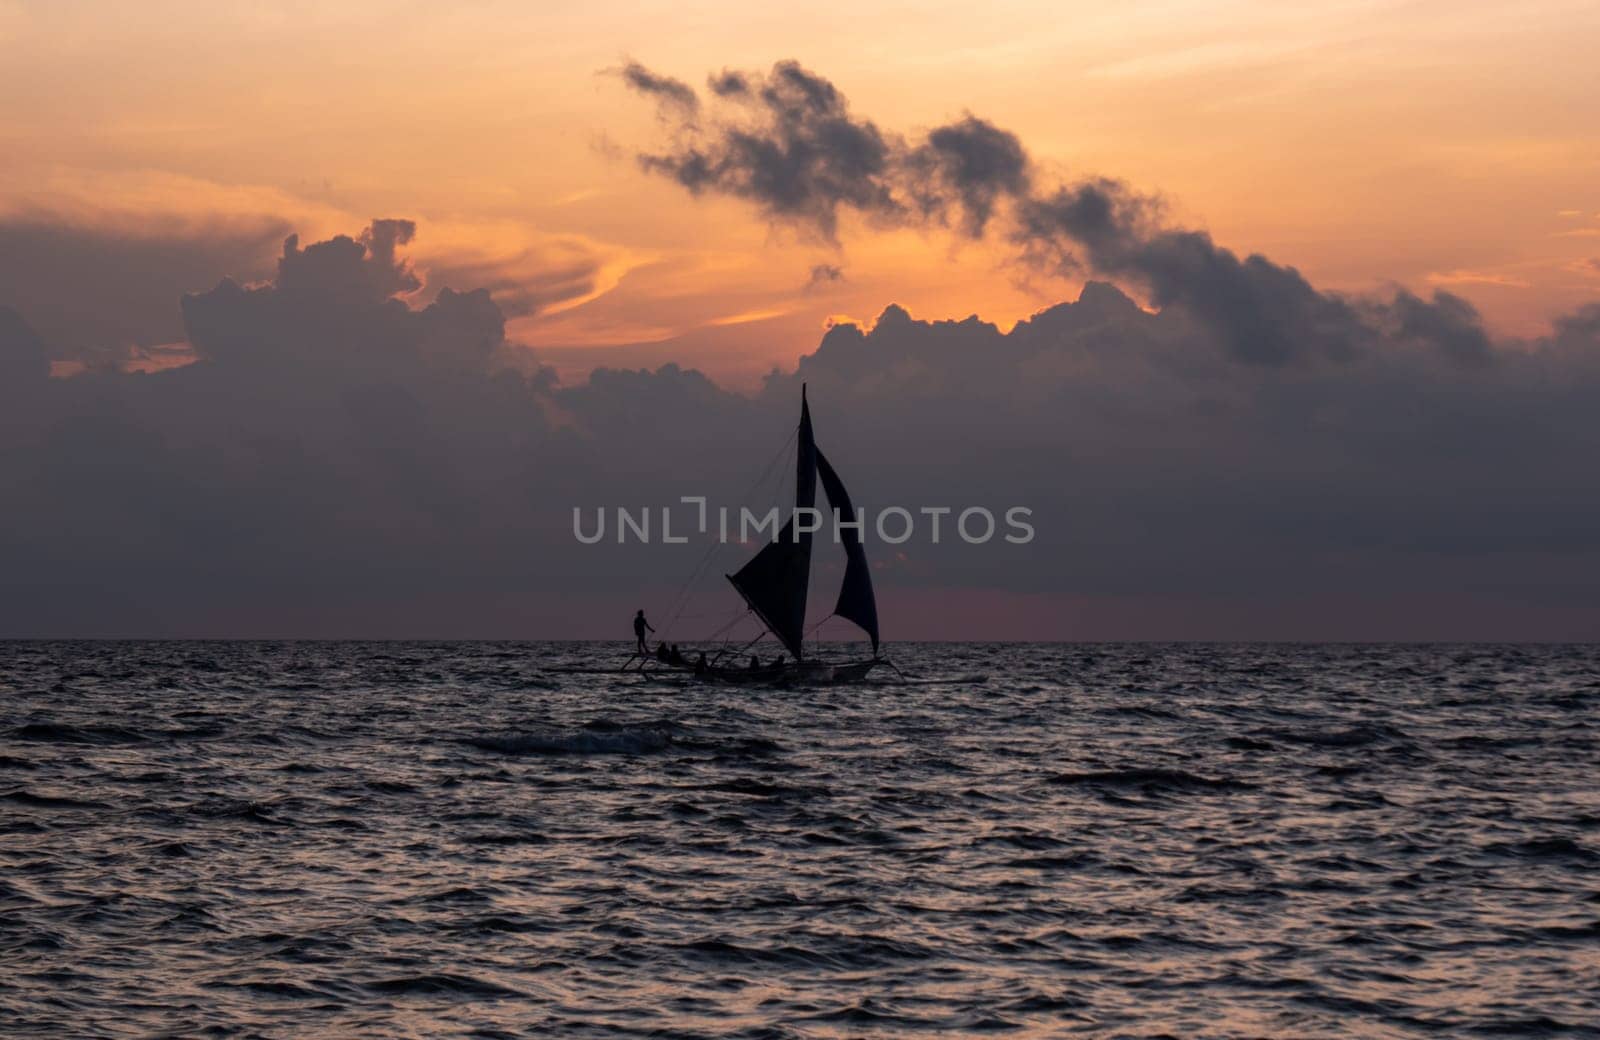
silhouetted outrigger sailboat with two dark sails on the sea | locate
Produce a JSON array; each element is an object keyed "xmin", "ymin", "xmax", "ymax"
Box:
[{"xmin": 642, "ymin": 384, "xmax": 886, "ymax": 683}]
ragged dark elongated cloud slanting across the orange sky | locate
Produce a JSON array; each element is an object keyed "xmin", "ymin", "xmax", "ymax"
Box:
[{"xmin": 617, "ymin": 61, "xmax": 1516, "ymax": 366}]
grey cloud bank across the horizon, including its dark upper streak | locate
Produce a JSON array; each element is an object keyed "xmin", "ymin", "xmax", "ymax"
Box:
[{"xmin": 0, "ymin": 62, "xmax": 1600, "ymax": 643}]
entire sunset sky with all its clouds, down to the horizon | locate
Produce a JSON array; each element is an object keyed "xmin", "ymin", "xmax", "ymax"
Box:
[{"xmin": 0, "ymin": 0, "xmax": 1600, "ymax": 638}]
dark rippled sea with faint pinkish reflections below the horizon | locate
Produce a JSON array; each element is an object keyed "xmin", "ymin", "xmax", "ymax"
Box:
[{"xmin": 0, "ymin": 643, "xmax": 1600, "ymax": 1037}]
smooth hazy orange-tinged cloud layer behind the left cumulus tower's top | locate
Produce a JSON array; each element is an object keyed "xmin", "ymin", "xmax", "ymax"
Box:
[{"xmin": 0, "ymin": 171, "xmax": 656, "ymax": 368}]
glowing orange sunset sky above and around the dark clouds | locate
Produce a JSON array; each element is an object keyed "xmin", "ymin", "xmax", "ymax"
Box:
[{"xmin": 0, "ymin": 0, "xmax": 1600, "ymax": 386}]
